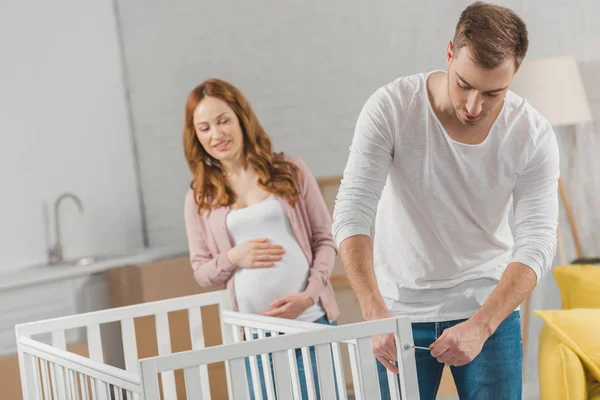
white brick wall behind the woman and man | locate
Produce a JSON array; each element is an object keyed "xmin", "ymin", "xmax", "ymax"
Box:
[{"xmin": 118, "ymin": 0, "xmax": 600, "ymax": 394}]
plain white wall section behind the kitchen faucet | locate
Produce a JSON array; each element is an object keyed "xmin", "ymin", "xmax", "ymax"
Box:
[{"xmin": 0, "ymin": 0, "xmax": 142, "ymax": 270}]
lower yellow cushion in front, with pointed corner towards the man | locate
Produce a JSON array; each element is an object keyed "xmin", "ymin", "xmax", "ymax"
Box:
[{"xmin": 534, "ymin": 308, "xmax": 600, "ymax": 381}]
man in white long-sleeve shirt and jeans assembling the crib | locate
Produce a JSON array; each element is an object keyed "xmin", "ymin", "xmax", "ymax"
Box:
[{"xmin": 333, "ymin": 2, "xmax": 559, "ymax": 400}]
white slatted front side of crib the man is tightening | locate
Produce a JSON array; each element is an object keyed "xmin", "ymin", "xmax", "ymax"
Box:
[{"xmin": 140, "ymin": 315, "xmax": 419, "ymax": 400}]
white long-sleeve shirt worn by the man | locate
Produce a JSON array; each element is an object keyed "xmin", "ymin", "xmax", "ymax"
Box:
[{"xmin": 333, "ymin": 74, "xmax": 559, "ymax": 322}]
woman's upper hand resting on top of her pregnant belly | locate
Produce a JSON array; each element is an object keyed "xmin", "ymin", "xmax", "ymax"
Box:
[{"xmin": 227, "ymin": 238, "xmax": 285, "ymax": 268}]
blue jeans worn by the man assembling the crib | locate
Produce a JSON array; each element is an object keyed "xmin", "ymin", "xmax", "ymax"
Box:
[{"xmin": 377, "ymin": 311, "xmax": 523, "ymax": 400}]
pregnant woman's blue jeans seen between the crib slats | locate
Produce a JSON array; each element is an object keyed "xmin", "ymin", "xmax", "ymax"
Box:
[{"xmin": 244, "ymin": 316, "xmax": 337, "ymax": 400}]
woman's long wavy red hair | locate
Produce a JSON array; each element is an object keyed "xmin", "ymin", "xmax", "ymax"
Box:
[{"xmin": 183, "ymin": 79, "xmax": 300, "ymax": 213}]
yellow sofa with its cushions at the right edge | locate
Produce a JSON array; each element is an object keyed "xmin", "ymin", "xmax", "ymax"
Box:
[{"xmin": 534, "ymin": 265, "xmax": 600, "ymax": 400}]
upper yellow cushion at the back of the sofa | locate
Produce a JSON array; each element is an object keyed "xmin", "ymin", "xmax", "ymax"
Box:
[{"xmin": 552, "ymin": 265, "xmax": 600, "ymax": 310}]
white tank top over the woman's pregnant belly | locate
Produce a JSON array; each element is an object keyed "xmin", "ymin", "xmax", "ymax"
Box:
[{"xmin": 227, "ymin": 196, "xmax": 325, "ymax": 322}]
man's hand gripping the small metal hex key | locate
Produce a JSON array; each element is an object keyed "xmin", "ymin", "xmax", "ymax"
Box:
[{"xmin": 429, "ymin": 319, "xmax": 490, "ymax": 367}]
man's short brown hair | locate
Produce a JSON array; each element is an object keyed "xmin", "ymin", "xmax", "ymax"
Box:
[{"xmin": 453, "ymin": 1, "xmax": 529, "ymax": 69}]
